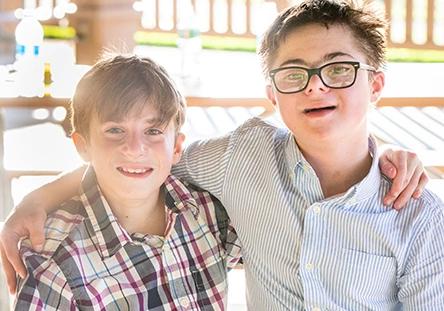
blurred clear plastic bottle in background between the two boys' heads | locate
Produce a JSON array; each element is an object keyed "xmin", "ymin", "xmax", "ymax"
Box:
[{"xmin": 176, "ymin": 2, "xmax": 202, "ymax": 80}]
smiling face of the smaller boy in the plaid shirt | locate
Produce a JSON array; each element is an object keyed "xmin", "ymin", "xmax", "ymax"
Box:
[{"xmin": 73, "ymin": 105, "xmax": 184, "ymax": 205}]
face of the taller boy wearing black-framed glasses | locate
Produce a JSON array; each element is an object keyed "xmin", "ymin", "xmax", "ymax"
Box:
[{"xmin": 266, "ymin": 24, "xmax": 384, "ymax": 146}]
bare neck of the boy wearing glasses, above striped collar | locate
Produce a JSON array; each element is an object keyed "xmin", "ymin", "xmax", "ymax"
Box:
[{"xmin": 298, "ymin": 136, "xmax": 372, "ymax": 198}]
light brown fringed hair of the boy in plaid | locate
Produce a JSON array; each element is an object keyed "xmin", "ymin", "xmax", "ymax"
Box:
[{"xmin": 71, "ymin": 52, "xmax": 186, "ymax": 139}]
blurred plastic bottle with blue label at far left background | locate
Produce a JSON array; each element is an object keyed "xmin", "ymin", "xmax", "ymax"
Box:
[{"xmin": 14, "ymin": 10, "xmax": 43, "ymax": 97}]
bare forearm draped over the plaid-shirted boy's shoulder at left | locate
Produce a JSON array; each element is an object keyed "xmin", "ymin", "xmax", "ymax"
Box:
[{"xmin": 20, "ymin": 165, "xmax": 87, "ymax": 213}]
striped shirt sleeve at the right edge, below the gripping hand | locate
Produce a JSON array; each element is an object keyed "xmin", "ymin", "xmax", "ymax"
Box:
[{"xmin": 398, "ymin": 203, "xmax": 444, "ymax": 310}]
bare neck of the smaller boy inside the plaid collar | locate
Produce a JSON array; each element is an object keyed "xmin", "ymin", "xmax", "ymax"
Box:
[{"xmin": 106, "ymin": 188, "xmax": 166, "ymax": 236}]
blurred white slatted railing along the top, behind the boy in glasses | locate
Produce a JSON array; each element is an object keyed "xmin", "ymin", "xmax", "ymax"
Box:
[{"xmin": 134, "ymin": 0, "xmax": 444, "ymax": 50}]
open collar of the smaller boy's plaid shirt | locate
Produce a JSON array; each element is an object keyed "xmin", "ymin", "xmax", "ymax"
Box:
[{"xmin": 80, "ymin": 166, "xmax": 199, "ymax": 260}]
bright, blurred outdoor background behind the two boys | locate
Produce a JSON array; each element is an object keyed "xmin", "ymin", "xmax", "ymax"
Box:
[{"xmin": 0, "ymin": 0, "xmax": 444, "ymax": 310}]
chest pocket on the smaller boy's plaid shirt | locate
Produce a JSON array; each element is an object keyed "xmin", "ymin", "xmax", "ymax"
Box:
[{"xmin": 191, "ymin": 257, "xmax": 228, "ymax": 310}]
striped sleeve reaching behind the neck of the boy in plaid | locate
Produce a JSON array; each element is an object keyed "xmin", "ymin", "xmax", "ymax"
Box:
[{"xmin": 172, "ymin": 134, "xmax": 231, "ymax": 199}]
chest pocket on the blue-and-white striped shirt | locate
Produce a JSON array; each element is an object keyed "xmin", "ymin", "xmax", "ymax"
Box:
[{"xmin": 338, "ymin": 249, "xmax": 398, "ymax": 310}]
